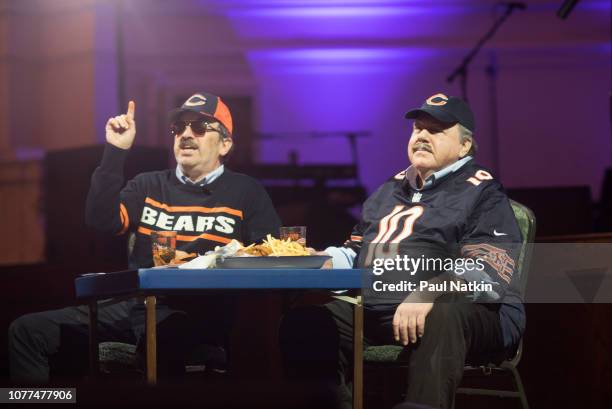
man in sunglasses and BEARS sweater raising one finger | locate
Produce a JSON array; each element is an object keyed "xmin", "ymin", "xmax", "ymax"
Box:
[{"xmin": 9, "ymin": 92, "xmax": 280, "ymax": 384}]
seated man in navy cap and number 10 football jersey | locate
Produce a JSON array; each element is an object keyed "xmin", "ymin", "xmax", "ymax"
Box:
[{"xmin": 280, "ymin": 94, "xmax": 525, "ymax": 408}]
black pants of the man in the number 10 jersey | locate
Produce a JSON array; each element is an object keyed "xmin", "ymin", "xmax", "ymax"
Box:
[{"xmin": 280, "ymin": 296, "xmax": 507, "ymax": 408}]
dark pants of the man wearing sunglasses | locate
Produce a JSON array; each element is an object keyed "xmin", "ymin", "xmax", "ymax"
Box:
[{"xmin": 8, "ymin": 294, "xmax": 234, "ymax": 384}]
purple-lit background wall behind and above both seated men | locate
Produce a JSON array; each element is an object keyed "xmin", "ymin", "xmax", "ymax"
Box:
[{"xmin": 0, "ymin": 0, "xmax": 612, "ymax": 197}]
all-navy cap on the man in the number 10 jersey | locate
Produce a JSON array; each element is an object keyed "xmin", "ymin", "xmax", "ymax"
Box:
[{"xmin": 406, "ymin": 94, "xmax": 476, "ymax": 132}]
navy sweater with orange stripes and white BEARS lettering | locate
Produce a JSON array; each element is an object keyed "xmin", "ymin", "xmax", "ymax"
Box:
[{"xmin": 85, "ymin": 144, "xmax": 280, "ymax": 268}]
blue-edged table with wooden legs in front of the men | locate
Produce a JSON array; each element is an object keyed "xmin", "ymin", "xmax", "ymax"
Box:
[{"xmin": 75, "ymin": 268, "xmax": 363, "ymax": 409}]
